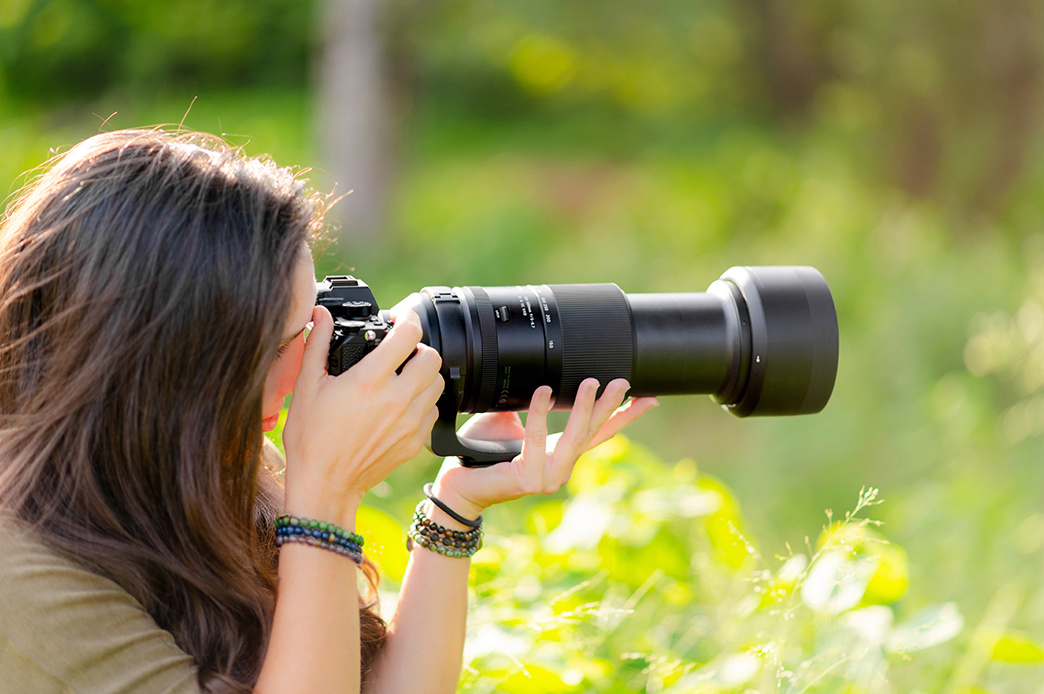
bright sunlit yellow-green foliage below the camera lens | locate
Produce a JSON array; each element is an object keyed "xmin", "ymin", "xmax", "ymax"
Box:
[{"xmin": 360, "ymin": 436, "xmax": 1027, "ymax": 694}]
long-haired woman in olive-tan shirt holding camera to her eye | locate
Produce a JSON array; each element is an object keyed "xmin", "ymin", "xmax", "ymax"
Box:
[{"xmin": 0, "ymin": 130, "xmax": 655, "ymax": 692}]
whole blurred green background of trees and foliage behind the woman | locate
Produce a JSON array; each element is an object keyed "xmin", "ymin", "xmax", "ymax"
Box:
[{"xmin": 6, "ymin": 0, "xmax": 1044, "ymax": 693}]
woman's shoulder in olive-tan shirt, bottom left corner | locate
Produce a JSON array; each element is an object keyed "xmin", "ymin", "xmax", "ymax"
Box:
[{"xmin": 0, "ymin": 521, "xmax": 199, "ymax": 693}]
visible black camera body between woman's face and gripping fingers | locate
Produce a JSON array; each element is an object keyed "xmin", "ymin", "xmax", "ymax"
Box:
[{"xmin": 315, "ymin": 274, "xmax": 392, "ymax": 376}]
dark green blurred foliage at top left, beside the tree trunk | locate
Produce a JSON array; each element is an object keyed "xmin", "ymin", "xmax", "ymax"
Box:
[{"xmin": 0, "ymin": 0, "xmax": 314, "ymax": 104}]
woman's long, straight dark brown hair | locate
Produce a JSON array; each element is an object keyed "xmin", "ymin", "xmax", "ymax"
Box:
[{"xmin": 0, "ymin": 129, "xmax": 384, "ymax": 692}]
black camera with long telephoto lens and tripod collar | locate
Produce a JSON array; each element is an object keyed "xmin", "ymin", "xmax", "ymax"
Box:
[{"xmin": 316, "ymin": 266, "xmax": 838, "ymax": 466}]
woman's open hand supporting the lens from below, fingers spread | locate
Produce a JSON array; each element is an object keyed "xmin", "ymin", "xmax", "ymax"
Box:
[{"xmin": 433, "ymin": 379, "xmax": 658, "ymax": 518}]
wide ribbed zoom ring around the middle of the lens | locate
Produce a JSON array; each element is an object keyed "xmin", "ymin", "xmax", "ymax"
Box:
[{"xmin": 551, "ymin": 284, "xmax": 635, "ymax": 404}]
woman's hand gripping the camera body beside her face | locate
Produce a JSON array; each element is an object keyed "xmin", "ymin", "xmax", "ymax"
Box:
[{"xmin": 283, "ymin": 306, "xmax": 444, "ymax": 526}]
